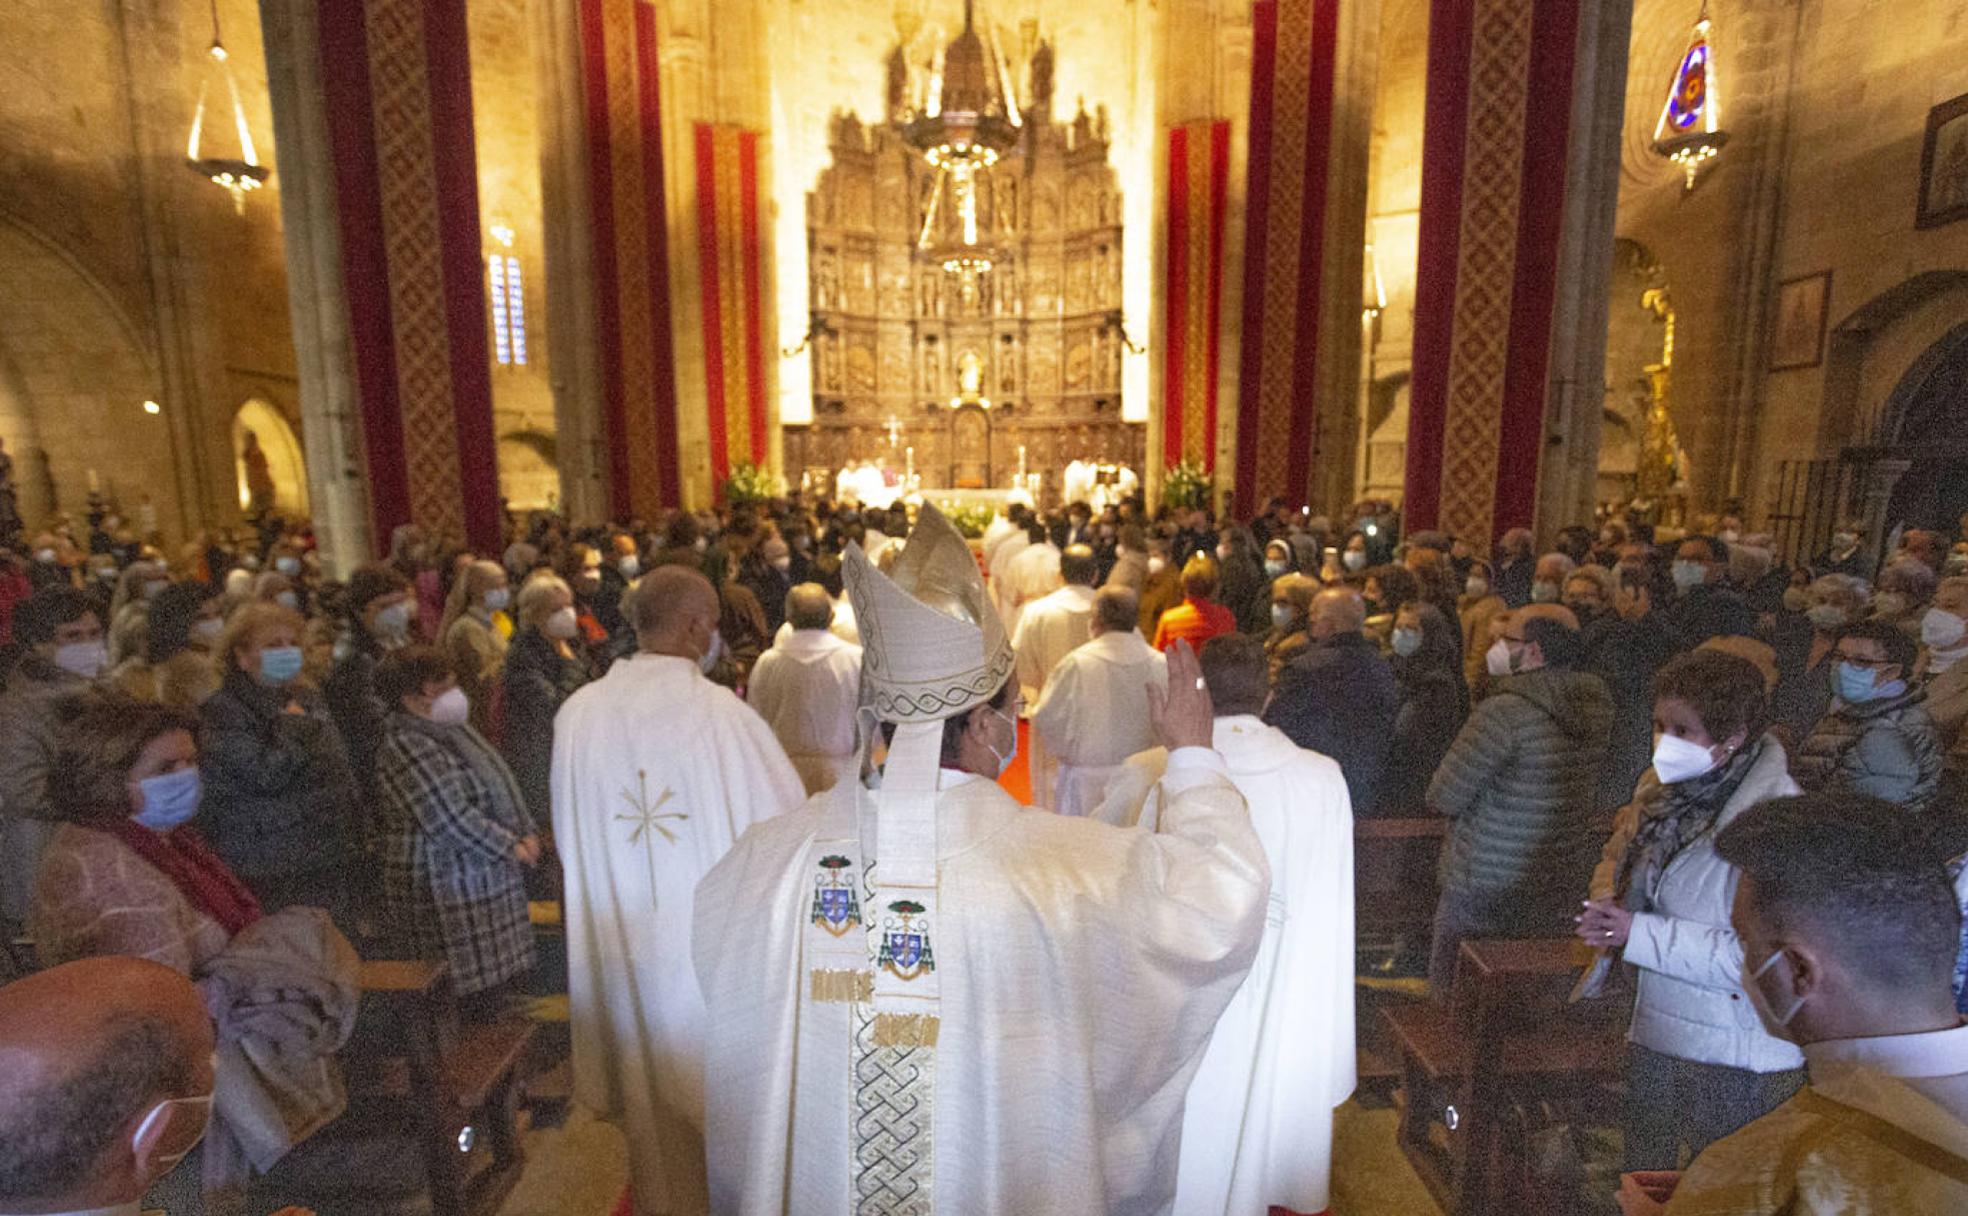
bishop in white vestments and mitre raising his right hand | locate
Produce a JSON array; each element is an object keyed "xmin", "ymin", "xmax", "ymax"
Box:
[{"xmin": 695, "ymin": 508, "xmax": 1267, "ymax": 1216}]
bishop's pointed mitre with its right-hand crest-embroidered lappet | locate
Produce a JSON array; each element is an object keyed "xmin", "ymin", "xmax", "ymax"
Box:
[{"xmin": 834, "ymin": 504, "xmax": 1012, "ymax": 1049}]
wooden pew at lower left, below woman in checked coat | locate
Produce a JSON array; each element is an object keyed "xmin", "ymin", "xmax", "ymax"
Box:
[{"xmin": 344, "ymin": 960, "xmax": 539, "ymax": 1216}]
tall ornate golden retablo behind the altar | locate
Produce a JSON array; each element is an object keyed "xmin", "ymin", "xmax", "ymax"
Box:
[{"xmin": 785, "ymin": 23, "xmax": 1143, "ymax": 500}]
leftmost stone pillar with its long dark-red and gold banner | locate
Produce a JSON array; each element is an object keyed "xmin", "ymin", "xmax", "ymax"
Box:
[{"xmin": 266, "ymin": 0, "xmax": 502, "ymax": 565}]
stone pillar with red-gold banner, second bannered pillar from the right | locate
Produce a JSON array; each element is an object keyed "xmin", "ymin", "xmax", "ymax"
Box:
[{"xmin": 1234, "ymin": 0, "xmax": 1380, "ymax": 514}]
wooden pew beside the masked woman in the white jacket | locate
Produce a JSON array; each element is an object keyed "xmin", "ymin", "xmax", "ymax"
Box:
[{"xmin": 1382, "ymin": 939, "xmax": 1628, "ymax": 1216}]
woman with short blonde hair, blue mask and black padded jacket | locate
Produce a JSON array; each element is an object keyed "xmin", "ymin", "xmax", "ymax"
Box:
[{"xmin": 199, "ymin": 604, "xmax": 360, "ymax": 933}]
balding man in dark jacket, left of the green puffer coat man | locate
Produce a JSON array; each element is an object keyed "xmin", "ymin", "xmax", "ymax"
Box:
[{"xmin": 1263, "ymin": 586, "xmax": 1401, "ymax": 815}]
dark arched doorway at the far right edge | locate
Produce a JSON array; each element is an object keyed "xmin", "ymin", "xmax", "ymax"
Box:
[{"xmin": 1879, "ymin": 323, "xmax": 1968, "ymax": 533}]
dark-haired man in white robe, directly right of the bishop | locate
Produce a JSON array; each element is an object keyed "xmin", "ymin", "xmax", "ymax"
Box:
[{"xmin": 1102, "ymin": 636, "xmax": 1356, "ymax": 1216}]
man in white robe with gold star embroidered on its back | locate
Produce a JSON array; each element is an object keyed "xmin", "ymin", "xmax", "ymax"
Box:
[{"xmin": 553, "ymin": 567, "xmax": 805, "ymax": 1216}]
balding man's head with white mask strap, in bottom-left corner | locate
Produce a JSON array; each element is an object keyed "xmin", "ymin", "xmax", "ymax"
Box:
[{"xmin": 0, "ymin": 958, "xmax": 216, "ymax": 1216}]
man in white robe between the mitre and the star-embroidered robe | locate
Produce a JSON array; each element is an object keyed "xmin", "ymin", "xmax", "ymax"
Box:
[{"xmin": 746, "ymin": 582, "xmax": 862, "ymax": 793}]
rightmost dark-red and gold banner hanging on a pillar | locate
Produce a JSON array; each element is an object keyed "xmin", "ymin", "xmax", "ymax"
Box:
[{"xmin": 1405, "ymin": 0, "xmax": 1610, "ymax": 547}]
